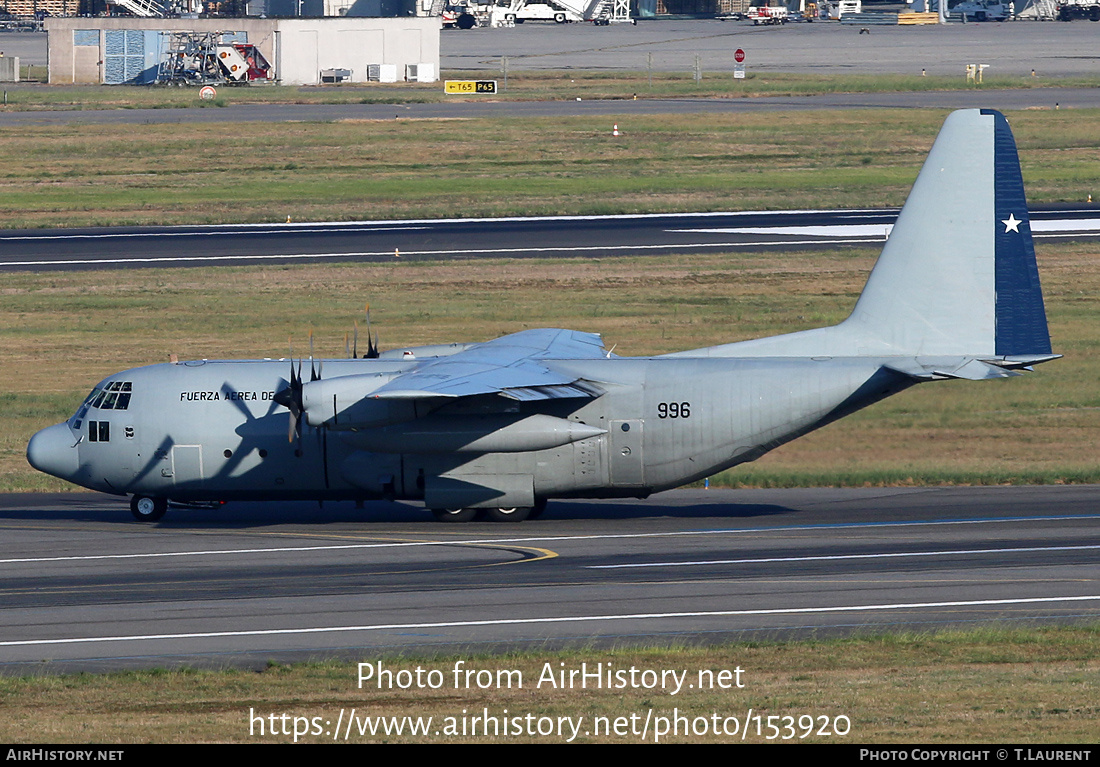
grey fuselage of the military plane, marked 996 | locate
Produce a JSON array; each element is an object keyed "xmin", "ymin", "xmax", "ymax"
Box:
[{"xmin": 29, "ymin": 358, "xmax": 912, "ymax": 507}]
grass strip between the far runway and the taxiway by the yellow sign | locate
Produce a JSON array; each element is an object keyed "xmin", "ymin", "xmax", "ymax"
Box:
[{"xmin": 0, "ymin": 110, "xmax": 1100, "ymax": 228}]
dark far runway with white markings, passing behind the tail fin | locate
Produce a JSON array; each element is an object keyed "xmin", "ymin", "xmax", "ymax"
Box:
[{"xmin": 0, "ymin": 205, "xmax": 1100, "ymax": 271}]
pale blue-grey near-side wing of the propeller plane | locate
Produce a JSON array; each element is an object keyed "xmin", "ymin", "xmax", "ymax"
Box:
[{"xmin": 370, "ymin": 329, "xmax": 607, "ymax": 401}]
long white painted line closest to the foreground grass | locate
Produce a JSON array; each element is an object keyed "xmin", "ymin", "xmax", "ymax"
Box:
[{"xmin": 0, "ymin": 594, "xmax": 1100, "ymax": 647}]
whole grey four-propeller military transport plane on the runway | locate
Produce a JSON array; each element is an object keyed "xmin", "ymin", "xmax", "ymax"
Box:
[{"xmin": 26, "ymin": 109, "xmax": 1059, "ymax": 522}]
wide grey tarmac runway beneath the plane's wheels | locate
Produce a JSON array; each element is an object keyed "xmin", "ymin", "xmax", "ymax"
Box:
[{"xmin": 0, "ymin": 486, "xmax": 1100, "ymax": 673}]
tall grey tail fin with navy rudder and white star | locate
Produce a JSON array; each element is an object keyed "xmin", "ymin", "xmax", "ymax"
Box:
[{"xmin": 677, "ymin": 109, "xmax": 1051, "ymax": 361}]
